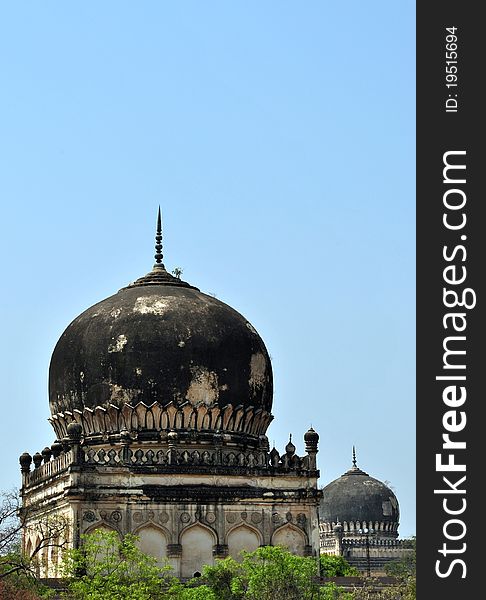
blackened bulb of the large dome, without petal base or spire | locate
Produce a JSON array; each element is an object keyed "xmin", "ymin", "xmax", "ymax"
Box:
[{"xmin": 49, "ymin": 284, "xmax": 272, "ymax": 414}]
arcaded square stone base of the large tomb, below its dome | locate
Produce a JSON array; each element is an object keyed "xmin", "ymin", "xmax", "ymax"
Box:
[{"xmin": 22, "ymin": 438, "xmax": 320, "ymax": 578}]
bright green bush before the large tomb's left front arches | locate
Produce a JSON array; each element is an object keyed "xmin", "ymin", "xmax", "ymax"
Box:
[{"xmin": 61, "ymin": 530, "xmax": 177, "ymax": 600}]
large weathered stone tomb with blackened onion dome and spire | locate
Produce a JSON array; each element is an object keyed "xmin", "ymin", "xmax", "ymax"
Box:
[{"xmin": 20, "ymin": 213, "xmax": 320, "ymax": 578}]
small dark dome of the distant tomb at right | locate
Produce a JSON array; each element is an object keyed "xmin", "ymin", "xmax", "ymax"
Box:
[{"xmin": 319, "ymin": 466, "xmax": 400, "ymax": 537}]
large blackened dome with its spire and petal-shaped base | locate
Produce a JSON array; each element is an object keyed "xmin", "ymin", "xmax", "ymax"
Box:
[{"xmin": 49, "ymin": 210, "xmax": 273, "ymax": 436}]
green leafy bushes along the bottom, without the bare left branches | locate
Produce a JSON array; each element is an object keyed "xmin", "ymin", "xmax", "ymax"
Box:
[{"xmin": 58, "ymin": 531, "xmax": 415, "ymax": 600}]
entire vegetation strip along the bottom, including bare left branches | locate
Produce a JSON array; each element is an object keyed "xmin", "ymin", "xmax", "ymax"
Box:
[{"xmin": 0, "ymin": 491, "xmax": 416, "ymax": 600}]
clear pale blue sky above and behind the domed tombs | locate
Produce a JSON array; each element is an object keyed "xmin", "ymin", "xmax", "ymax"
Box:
[{"xmin": 0, "ymin": 0, "xmax": 415, "ymax": 536}]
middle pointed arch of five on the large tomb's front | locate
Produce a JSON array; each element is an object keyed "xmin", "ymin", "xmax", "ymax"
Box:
[{"xmin": 180, "ymin": 523, "xmax": 217, "ymax": 578}]
